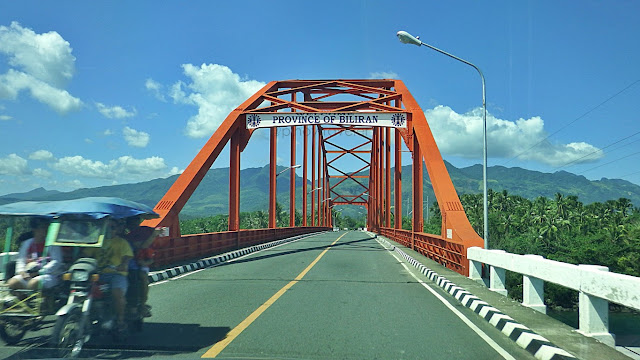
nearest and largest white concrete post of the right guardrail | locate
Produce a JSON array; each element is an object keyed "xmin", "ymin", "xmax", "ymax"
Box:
[{"xmin": 578, "ymin": 264, "xmax": 616, "ymax": 347}]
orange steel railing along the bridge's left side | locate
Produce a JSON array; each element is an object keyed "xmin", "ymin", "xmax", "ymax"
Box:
[{"xmin": 153, "ymin": 226, "xmax": 330, "ymax": 267}]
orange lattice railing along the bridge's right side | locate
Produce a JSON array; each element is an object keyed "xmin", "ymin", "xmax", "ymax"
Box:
[{"xmin": 380, "ymin": 228, "xmax": 468, "ymax": 275}]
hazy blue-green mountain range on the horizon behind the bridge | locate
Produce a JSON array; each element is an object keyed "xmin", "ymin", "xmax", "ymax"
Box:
[{"xmin": 0, "ymin": 162, "xmax": 640, "ymax": 219}]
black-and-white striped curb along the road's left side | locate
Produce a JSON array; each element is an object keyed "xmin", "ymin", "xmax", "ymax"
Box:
[{"xmin": 149, "ymin": 231, "xmax": 325, "ymax": 284}]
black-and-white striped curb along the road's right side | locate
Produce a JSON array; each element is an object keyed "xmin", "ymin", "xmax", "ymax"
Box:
[{"xmin": 372, "ymin": 234, "xmax": 577, "ymax": 360}]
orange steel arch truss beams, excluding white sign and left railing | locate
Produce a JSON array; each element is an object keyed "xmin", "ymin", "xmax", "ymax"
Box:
[{"xmin": 145, "ymin": 79, "xmax": 484, "ymax": 273}]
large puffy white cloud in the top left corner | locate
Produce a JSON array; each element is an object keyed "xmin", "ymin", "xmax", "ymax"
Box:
[{"xmin": 0, "ymin": 22, "xmax": 82, "ymax": 113}]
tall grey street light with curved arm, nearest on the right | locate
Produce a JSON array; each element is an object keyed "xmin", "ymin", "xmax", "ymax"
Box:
[{"xmin": 396, "ymin": 31, "xmax": 489, "ymax": 249}]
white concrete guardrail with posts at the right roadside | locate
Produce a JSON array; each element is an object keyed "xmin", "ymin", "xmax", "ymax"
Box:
[{"xmin": 467, "ymin": 247, "xmax": 640, "ymax": 346}]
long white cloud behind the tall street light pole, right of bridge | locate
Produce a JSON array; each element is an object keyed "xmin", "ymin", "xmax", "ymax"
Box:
[{"xmin": 425, "ymin": 105, "xmax": 603, "ymax": 166}]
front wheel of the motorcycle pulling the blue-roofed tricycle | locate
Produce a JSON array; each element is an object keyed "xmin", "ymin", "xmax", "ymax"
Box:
[{"xmin": 51, "ymin": 308, "xmax": 84, "ymax": 359}]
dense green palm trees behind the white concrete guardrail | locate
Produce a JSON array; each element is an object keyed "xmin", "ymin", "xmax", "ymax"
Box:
[{"xmin": 425, "ymin": 190, "xmax": 640, "ymax": 308}]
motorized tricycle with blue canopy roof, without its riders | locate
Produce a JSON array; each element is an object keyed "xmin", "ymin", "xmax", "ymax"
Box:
[{"xmin": 0, "ymin": 197, "xmax": 158, "ymax": 358}]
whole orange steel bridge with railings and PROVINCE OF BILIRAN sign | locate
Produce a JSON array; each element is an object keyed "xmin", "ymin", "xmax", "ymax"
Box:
[{"xmin": 146, "ymin": 79, "xmax": 484, "ymax": 274}]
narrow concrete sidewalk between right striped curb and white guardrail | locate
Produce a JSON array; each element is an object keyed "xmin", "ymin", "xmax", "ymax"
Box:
[{"xmin": 385, "ymin": 237, "xmax": 629, "ymax": 360}]
